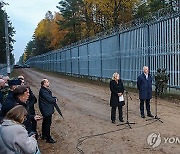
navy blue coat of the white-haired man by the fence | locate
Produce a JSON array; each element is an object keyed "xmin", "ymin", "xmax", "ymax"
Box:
[{"xmin": 137, "ymin": 73, "xmax": 152, "ymax": 99}]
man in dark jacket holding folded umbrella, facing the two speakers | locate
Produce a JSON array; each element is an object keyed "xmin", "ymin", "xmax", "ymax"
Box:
[{"xmin": 39, "ymin": 79, "xmax": 57, "ymax": 143}]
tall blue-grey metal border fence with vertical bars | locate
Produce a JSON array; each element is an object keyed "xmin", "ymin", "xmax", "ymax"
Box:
[{"xmin": 26, "ymin": 12, "xmax": 180, "ymax": 88}]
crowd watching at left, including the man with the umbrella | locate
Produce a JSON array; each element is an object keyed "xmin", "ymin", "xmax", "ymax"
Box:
[{"xmin": 0, "ymin": 75, "xmax": 57, "ymax": 154}]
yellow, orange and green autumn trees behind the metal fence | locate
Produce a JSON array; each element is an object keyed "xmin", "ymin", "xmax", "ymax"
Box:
[{"xmin": 21, "ymin": 0, "xmax": 179, "ymax": 61}]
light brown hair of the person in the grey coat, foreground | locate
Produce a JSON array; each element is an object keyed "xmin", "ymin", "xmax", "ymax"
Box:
[{"xmin": 5, "ymin": 105, "xmax": 27, "ymax": 123}]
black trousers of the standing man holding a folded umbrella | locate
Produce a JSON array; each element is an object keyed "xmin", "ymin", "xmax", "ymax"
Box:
[{"xmin": 42, "ymin": 115, "xmax": 52, "ymax": 140}]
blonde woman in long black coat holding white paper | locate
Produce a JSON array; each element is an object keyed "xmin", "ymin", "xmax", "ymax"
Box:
[{"xmin": 110, "ymin": 72, "xmax": 124, "ymax": 123}]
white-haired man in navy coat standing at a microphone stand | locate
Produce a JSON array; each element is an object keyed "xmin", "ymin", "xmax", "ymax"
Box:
[{"xmin": 137, "ymin": 66, "xmax": 153, "ymax": 118}]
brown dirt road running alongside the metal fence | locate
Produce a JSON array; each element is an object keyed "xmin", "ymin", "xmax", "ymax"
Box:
[{"xmin": 16, "ymin": 69, "xmax": 180, "ymax": 154}]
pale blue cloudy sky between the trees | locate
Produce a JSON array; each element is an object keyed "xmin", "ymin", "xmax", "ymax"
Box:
[{"xmin": 4, "ymin": 0, "xmax": 60, "ymax": 62}]
